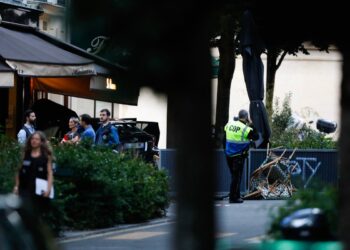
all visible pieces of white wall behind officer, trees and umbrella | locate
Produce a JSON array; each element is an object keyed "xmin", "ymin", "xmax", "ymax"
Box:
[{"xmin": 212, "ymin": 47, "xmax": 342, "ymax": 139}]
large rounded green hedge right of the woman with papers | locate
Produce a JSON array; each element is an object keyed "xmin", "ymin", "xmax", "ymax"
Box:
[{"xmin": 55, "ymin": 145, "xmax": 168, "ymax": 228}]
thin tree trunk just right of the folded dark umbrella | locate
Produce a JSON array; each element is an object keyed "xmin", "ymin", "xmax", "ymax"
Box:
[{"xmin": 266, "ymin": 49, "xmax": 278, "ymax": 121}]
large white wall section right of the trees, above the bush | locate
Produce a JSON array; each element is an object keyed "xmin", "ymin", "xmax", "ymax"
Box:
[{"xmin": 275, "ymin": 51, "xmax": 342, "ymax": 132}]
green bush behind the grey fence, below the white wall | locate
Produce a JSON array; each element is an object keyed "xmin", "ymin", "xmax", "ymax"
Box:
[{"xmin": 270, "ymin": 94, "xmax": 336, "ymax": 149}]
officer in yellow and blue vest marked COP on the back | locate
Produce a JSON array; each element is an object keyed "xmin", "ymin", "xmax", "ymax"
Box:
[{"xmin": 225, "ymin": 109, "xmax": 259, "ymax": 203}]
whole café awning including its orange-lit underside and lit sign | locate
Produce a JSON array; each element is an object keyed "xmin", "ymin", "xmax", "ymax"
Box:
[{"xmin": 0, "ymin": 22, "xmax": 139, "ymax": 105}]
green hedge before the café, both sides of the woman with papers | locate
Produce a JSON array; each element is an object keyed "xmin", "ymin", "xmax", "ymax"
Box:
[{"xmin": 0, "ymin": 136, "xmax": 169, "ymax": 233}]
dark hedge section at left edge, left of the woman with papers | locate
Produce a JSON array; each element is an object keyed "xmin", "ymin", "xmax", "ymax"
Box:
[{"xmin": 0, "ymin": 134, "xmax": 21, "ymax": 194}]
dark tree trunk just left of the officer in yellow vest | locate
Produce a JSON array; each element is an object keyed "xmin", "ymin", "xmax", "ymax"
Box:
[{"xmin": 215, "ymin": 14, "xmax": 236, "ymax": 148}]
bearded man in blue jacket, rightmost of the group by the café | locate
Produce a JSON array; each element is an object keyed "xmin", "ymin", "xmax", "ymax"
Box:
[{"xmin": 95, "ymin": 109, "xmax": 120, "ymax": 149}]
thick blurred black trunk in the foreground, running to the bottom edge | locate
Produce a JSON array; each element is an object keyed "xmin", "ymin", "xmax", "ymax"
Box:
[{"xmin": 169, "ymin": 81, "xmax": 214, "ymax": 250}]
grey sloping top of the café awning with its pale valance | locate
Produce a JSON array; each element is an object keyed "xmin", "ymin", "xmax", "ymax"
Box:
[{"xmin": 0, "ymin": 22, "xmax": 118, "ymax": 77}]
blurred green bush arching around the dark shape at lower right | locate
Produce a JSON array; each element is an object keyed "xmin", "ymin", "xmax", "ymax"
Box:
[{"xmin": 268, "ymin": 186, "xmax": 339, "ymax": 239}]
